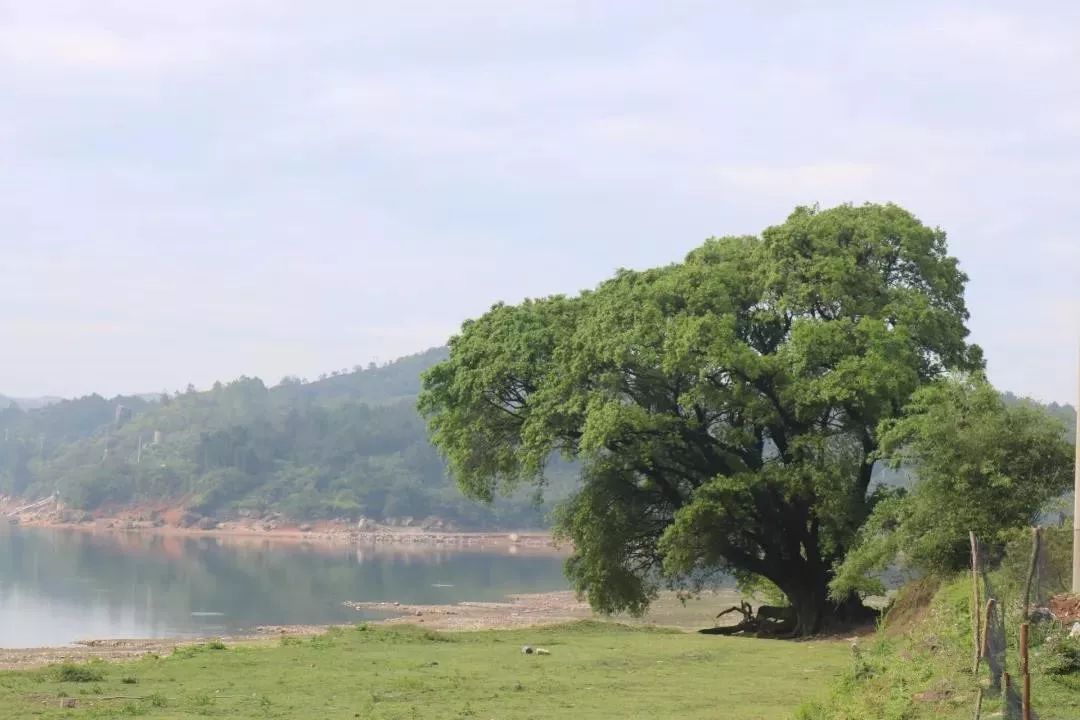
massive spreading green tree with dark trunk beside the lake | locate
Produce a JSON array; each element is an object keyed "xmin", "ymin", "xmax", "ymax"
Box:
[{"xmin": 420, "ymin": 205, "xmax": 982, "ymax": 634}]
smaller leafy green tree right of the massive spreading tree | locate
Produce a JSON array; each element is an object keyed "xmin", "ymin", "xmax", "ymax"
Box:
[{"xmin": 833, "ymin": 376, "xmax": 1072, "ymax": 595}]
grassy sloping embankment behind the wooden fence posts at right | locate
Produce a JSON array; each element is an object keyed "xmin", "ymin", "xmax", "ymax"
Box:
[{"xmin": 798, "ymin": 578, "xmax": 1080, "ymax": 720}]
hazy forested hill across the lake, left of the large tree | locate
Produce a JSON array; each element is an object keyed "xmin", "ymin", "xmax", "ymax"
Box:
[{"xmin": 0, "ymin": 348, "xmax": 571, "ymax": 528}]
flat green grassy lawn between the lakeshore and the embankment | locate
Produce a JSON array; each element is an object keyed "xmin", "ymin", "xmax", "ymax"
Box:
[{"xmin": 0, "ymin": 621, "xmax": 851, "ymax": 720}]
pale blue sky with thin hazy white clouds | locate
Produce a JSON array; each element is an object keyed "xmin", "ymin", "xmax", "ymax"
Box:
[{"xmin": 0, "ymin": 0, "xmax": 1080, "ymax": 402}]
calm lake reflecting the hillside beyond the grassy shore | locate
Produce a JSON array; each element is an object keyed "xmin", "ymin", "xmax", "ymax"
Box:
[{"xmin": 0, "ymin": 526, "xmax": 567, "ymax": 648}]
